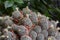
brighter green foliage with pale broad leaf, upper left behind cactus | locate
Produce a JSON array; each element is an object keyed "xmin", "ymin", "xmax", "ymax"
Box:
[{"xmin": 0, "ymin": 0, "xmax": 27, "ymax": 15}]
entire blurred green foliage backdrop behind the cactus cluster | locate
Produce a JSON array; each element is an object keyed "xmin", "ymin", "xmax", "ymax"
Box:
[{"xmin": 0, "ymin": 0, "xmax": 60, "ymax": 21}]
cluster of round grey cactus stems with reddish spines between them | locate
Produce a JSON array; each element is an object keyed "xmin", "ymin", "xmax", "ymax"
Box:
[{"xmin": 0, "ymin": 8, "xmax": 60, "ymax": 40}]
